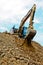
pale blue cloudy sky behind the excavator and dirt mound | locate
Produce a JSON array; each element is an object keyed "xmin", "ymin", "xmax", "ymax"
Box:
[{"xmin": 0, "ymin": 0, "xmax": 43, "ymax": 45}]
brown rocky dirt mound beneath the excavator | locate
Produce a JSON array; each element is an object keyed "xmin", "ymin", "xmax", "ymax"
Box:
[{"xmin": 0, "ymin": 33, "xmax": 43, "ymax": 65}]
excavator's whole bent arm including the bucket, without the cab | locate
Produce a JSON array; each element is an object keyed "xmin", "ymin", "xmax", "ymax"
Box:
[{"xmin": 18, "ymin": 4, "xmax": 36, "ymax": 39}]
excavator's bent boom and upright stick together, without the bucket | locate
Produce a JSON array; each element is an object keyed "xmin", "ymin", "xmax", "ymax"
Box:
[{"xmin": 18, "ymin": 4, "xmax": 36, "ymax": 37}]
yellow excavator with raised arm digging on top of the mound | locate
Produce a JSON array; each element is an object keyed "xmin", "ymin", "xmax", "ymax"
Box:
[{"xmin": 10, "ymin": 4, "xmax": 36, "ymax": 40}]
